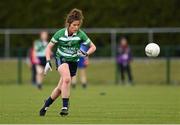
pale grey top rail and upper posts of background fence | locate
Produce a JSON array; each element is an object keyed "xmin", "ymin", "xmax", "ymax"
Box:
[{"xmin": 0, "ymin": 27, "xmax": 180, "ymax": 58}]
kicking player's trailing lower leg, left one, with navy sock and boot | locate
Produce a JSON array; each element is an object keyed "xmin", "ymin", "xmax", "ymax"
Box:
[{"xmin": 39, "ymin": 79, "xmax": 62, "ymax": 116}]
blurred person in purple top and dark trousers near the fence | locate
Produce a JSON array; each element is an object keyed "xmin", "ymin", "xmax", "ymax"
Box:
[{"xmin": 117, "ymin": 36, "xmax": 133, "ymax": 85}]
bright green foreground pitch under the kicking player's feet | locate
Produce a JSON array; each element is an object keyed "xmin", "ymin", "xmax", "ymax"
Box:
[{"xmin": 0, "ymin": 84, "xmax": 180, "ymax": 124}]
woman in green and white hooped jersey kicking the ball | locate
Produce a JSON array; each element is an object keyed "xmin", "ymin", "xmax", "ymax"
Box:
[{"xmin": 40, "ymin": 9, "xmax": 96, "ymax": 116}]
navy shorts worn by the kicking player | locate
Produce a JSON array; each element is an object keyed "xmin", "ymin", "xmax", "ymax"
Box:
[{"xmin": 55, "ymin": 57, "xmax": 77, "ymax": 77}]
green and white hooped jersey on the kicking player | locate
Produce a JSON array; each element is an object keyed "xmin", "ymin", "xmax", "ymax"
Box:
[{"xmin": 51, "ymin": 28, "xmax": 91, "ymax": 62}]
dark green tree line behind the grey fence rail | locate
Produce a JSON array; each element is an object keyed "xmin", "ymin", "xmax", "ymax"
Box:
[{"xmin": 0, "ymin": 0, "xmax": 180, "ymax": 56}]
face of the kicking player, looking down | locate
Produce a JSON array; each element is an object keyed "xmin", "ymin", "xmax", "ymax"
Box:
[{"xmin": 68, "ymin": 20, "xmax": 80, "ymax": 34}]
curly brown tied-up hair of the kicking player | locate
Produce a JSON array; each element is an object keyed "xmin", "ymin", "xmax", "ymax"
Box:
[{"xmin": 65, "ymin": 8, "xmax": 84, "ymax": 27}]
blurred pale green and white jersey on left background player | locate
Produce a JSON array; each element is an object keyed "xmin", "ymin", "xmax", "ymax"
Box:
[{"xmin": 34, "ymin": 40, "xmax": 48, "ymax": 57}]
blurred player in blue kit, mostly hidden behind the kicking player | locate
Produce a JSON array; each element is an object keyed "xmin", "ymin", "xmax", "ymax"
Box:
[{"xmin": 72, "ymin": 44, "xmax": 89, "ymax": 88}]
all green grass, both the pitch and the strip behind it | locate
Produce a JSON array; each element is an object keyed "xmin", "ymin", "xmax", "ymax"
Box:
[{"xmin": 0, "ymin": 59, "xmax": 180, "ymax": 124}]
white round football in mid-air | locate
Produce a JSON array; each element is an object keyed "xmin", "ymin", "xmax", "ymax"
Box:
[{"xmin": 145, "ymin": 43, "xmax": 160, "ymax": 57}]
